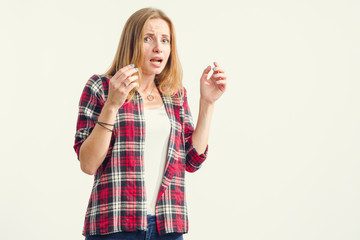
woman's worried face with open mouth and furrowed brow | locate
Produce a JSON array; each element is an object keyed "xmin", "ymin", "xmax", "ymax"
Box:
[{"xmin": 141, "ymin": 18, "xmax": 171, "ymax": 77}]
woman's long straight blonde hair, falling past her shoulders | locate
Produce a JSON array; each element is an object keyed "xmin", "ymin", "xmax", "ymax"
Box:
[{"xmin": 105, "ymin": 8, "xmax": 184, "ymax": 100}]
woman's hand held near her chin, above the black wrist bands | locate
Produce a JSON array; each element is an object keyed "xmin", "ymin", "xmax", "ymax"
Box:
[{"xmin": 106, "ymin": 64, "xmax": 139, "ymax": 109}]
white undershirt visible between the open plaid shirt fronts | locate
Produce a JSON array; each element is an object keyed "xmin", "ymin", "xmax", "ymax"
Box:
[{"xmin": 144, "ymin": 105, "xmax": 170, "ymax": 215}]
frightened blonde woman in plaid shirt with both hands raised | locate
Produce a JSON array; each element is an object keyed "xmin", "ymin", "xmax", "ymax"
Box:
[{"xmin": 74, "ymin": 8, "xmax": 226, "ymax": 240}]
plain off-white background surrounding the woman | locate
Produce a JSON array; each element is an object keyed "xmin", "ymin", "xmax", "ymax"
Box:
[{"xmin": 0, "ymin": 0, "xmax": 360, "ymax": 240}]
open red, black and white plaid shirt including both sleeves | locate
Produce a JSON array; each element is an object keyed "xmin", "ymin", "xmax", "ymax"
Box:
[{"xmin": 74, "ymin": 75, "xmax": 207, "ymax": 236}]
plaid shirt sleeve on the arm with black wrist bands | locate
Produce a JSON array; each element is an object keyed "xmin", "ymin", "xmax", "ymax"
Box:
[{"xmin": 74, "ymin": 75, "xmax": 104, "ymax": 159}]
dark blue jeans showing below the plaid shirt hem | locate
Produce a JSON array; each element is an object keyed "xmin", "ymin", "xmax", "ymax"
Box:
[{"xmin": 85, "ymin": 215, "xmax": 183, "ymax": 240}]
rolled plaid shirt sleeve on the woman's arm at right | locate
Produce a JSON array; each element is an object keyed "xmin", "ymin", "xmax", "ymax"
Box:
[{"xmin": 182, "ymin": 88, "xmax": 208, "ymax": 172}]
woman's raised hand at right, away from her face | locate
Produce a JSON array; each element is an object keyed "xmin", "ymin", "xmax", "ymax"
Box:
[{"xmin": 200, "ymin": 62, "xmax": 226, "ymax": 104}]
